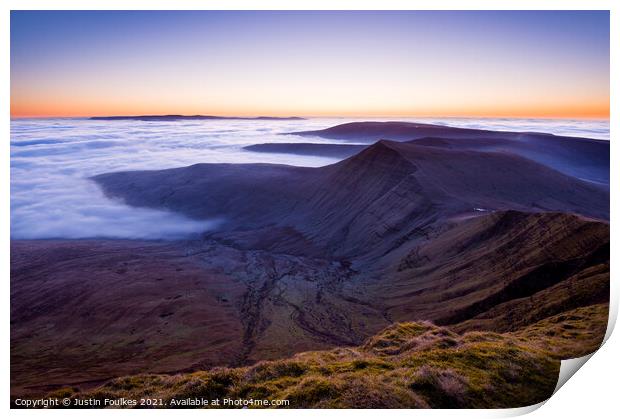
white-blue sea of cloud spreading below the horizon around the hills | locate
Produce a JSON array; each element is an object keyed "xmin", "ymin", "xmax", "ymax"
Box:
[{"xmin": 11, "ymin": 118, "xmax": 609, "ymax": 239}]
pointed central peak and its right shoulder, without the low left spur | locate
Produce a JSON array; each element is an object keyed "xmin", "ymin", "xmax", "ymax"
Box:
[{"xmin": 298, "ymin": 141, "xmax": 609, "ymax": 257}]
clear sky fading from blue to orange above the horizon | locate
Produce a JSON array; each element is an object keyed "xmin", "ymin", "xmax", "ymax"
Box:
[{"xmin": 11, "ymin": 11, "xmax": 609, "ymax": 118}]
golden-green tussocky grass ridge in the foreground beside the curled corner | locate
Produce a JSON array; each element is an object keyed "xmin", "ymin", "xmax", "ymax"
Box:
[{"xmin": 49, "ymin": 304, "xmax": 608, "ymax": 408}]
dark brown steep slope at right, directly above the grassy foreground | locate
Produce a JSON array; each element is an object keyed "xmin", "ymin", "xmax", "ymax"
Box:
[{"xmin": 366, "ymin": 211, "xmax": 609, "ymax": 331}]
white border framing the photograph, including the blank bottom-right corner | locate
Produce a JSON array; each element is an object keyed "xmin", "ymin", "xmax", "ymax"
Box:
[{"xmin": 0, "ymin": 0, "xmax": 620, "ymax": 419}]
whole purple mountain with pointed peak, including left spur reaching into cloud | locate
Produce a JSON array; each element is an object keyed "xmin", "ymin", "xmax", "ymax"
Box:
[{"xmin": 94, "ymin": 141, "xmax": 609, "ymax": 258}]
